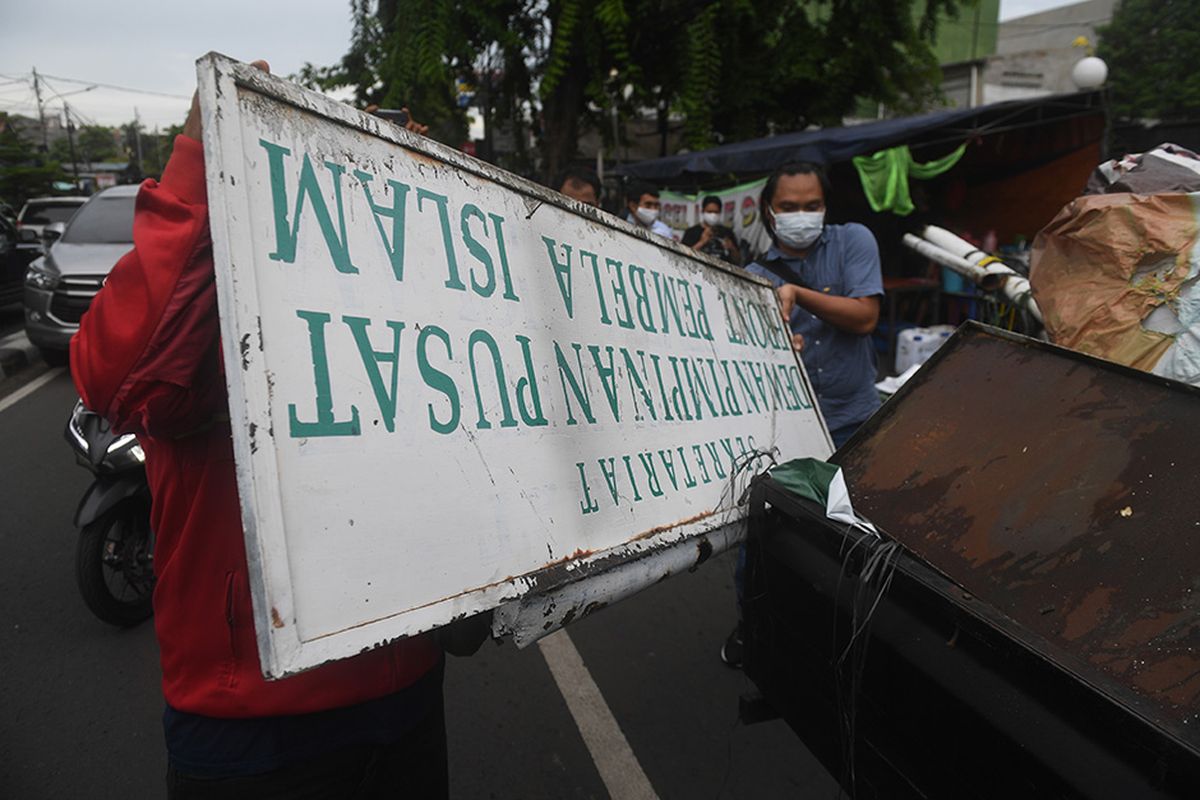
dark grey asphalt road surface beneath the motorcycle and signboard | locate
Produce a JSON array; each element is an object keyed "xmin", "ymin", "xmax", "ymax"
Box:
[{"xmin": 0, "ymin": 367, "xmax": 838, "ymax": 800}]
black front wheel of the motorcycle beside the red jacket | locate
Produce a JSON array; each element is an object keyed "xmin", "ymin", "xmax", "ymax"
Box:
[{"xmin": 76, "ymin": 497, "xmax": 154, "ymax": 627}]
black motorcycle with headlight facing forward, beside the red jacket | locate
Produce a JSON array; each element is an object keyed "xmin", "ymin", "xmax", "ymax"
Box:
[{"xmin": 65, "ymin": 401, "xmax": 154, "ymax": 627}]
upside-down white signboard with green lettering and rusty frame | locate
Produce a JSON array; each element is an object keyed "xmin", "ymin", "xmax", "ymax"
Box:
[{"xmin": 199, "ymin": 54, "xmax": 830, "ymax": 676}]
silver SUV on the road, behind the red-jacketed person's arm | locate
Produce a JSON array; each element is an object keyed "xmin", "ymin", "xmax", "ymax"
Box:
[{"xmin": 24, "ymin": 186, "xmax": 138, "ymax": 363}]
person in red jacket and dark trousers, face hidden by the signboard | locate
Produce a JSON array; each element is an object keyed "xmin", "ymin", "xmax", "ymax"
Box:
[{"xmin": 71, "ymin": 61, "xmax": 446, "ymax": 800}]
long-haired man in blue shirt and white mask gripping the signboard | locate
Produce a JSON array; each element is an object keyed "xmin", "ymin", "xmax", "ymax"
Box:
[{"xmin": 746, "ymin": 163, "xmax": 883, "ymax": 447}]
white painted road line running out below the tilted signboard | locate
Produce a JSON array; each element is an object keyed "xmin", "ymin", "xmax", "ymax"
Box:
[{"xmin": 538, "ymin": 631, "xmax": 659, "ymax": 800}]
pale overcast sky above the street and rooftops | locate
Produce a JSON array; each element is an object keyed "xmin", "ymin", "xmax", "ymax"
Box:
[{"xmin": 0, "ymin": 0, "xmax": 1068, "ymax": 130}]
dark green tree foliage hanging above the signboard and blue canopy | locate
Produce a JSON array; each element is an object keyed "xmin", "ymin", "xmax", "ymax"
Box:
[{"xmin": 300, "ymin": 0, "xmax": 972, "ymax": 178}]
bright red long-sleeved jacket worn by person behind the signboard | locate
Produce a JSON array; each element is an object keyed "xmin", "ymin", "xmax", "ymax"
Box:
[{"xmin": 71, "ymin": 136, "xmax": 440, "ymax": 718}]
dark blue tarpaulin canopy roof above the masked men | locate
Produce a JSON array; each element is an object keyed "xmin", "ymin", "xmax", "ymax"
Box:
[{"xmin": 617, "ymin": 91, "xmax": 1103, "ymax": 185}]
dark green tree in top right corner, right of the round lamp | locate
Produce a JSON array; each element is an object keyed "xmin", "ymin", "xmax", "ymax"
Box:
[{"xmin": 1097, "ymin": 0, "xmax": 1200, "ymax": 119}]
